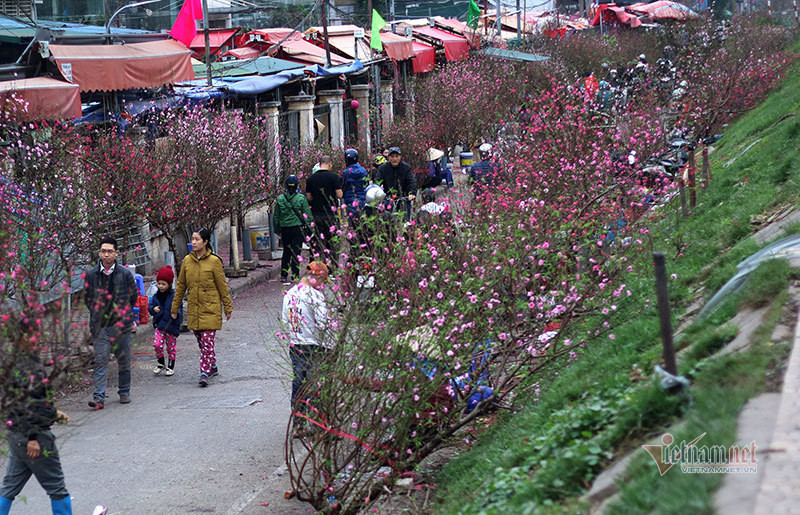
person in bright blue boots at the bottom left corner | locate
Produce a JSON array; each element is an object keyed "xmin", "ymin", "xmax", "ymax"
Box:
[{"xmin": 0, "ymin": 324, "xmax": 72, "ymax": 515}]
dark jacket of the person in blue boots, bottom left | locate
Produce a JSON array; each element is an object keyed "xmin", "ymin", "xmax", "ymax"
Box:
[{"xmin": 6, "ymin": 354, "xmax": 58, "ymax": 440}]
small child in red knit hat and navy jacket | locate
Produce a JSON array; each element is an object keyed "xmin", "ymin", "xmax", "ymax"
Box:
[{"xmin": 148, "ymin": 266, "xmax": 183, "ymax": 376}]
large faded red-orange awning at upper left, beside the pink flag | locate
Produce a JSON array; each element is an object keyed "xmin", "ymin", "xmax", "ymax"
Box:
[{"xmin": 50, "ymin": 39, "xmax": 194, "ymax": 91}]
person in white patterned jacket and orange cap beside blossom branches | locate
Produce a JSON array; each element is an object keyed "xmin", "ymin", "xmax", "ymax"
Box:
[{"xmin": 281, "ymin": 261, "xmax": 330, "ymax": 409}]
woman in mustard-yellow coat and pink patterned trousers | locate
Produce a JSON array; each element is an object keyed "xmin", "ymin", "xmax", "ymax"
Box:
[{"xmin": 171, "ymin": 229, "xmax": 233, "ymax": 387}]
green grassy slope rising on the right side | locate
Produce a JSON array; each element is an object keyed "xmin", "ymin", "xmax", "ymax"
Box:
[{"xmin": 437, "ymin": 38, "xmax": 800, "ymax": 513}]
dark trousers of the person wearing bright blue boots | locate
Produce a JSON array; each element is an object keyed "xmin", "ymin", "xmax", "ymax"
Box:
[{"xmin": 0, "ymin": 430, "xmax": 69, "ymax": 501}]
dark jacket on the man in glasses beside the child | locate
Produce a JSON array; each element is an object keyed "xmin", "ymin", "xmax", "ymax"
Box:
[{"xmin": 84, "ymin": 263, "xmax": 139, "ymax": 336}]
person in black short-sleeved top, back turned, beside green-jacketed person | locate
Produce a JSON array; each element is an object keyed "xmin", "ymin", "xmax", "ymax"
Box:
[{"xmin": 306, "ymin": 155, "xmax": 344, "ymax": 267}]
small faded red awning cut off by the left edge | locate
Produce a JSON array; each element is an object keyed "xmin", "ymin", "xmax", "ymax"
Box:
[{"xmin": 0, "ymin": 77, "xmax": 81, "ymax": 122}]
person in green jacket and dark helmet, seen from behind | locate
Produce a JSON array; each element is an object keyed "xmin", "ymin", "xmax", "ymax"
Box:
[{"xmin": 273, "ymin": 175, "xmax": 311, "ymax": 285}]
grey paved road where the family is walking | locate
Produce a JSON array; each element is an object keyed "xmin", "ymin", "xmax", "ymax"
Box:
[{"xmin": 0, "ymin": 281, "xmax": 309, "ymax": 515}]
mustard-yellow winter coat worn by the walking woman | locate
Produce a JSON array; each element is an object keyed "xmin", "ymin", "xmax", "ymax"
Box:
[{"xmin": 170, "ymin": 249, "xmax": 233, "ymax": 331}]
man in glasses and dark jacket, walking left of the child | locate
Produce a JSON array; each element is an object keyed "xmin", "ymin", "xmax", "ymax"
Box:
[{"xmin": 84, "ymin": 236, "xmax": 139, "ymax": 410}]
